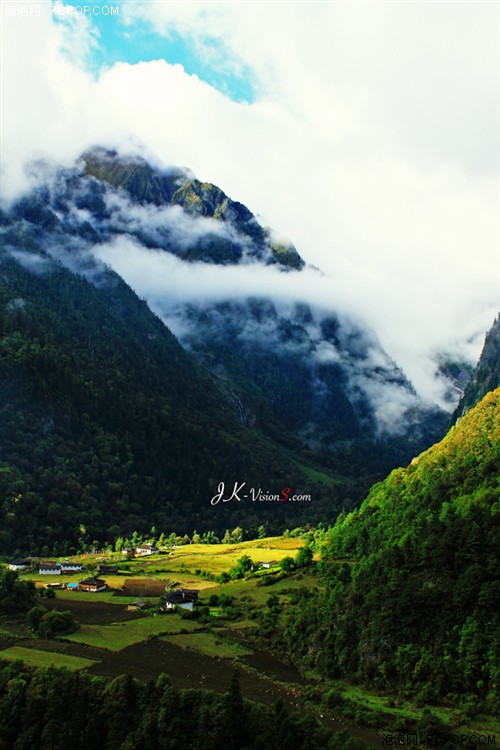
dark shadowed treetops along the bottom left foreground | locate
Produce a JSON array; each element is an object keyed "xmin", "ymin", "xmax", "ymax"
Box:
[{"xmin": 0, "ymin": 663, "xmax": 363, "ymax": 750}]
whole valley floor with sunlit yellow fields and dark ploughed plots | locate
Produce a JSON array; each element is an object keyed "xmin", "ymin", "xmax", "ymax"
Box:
[{"xmin": 0, "ymin": 535, "xmax": 500, "ymax": 747}]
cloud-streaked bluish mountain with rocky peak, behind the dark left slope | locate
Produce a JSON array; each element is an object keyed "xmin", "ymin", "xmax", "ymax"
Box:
[{"xmin": 79, "ymin": 149, "xmax": 447, "ymax": 462}]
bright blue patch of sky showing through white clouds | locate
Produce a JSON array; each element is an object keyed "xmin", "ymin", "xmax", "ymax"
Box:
[{"xmin": 53, "ymin": 0, "xmax": 255, "ymax": 103}]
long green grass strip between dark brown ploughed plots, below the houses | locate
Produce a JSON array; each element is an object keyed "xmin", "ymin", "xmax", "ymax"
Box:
[{"xmin": 66, "ymin": 614, "xmax": 199, "ymax": 651}]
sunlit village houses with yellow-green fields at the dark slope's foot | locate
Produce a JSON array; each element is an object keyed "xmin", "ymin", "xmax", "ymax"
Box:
[{"xmin": 6, "ymin": 539, "xmax": 290, "ymax": 613}]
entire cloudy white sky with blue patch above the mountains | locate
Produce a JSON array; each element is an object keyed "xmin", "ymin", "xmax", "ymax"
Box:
[{"xmin": 0, "ymin": 0, "xmax": 500, "ymax": 400}]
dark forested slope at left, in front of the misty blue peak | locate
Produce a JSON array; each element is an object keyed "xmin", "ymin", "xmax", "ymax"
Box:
[{"xmin": 0, "ymin": 250, "xmax": 342, "ymax": 554}]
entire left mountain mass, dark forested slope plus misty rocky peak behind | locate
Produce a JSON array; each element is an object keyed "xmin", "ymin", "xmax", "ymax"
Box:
[{"xmin": 0, "ymin": 149, "xmax": 446, "ymax": 553}]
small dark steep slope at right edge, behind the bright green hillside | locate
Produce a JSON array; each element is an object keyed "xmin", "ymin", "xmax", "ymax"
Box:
[{"xmin": 452, "ymin": 315, "xmax": 500, "ymax": 424}]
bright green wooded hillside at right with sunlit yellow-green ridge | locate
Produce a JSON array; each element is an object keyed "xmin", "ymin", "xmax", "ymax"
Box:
[{"xmin": 285, "ymin": 389, "xmax": 500, "ymax": 714}]
